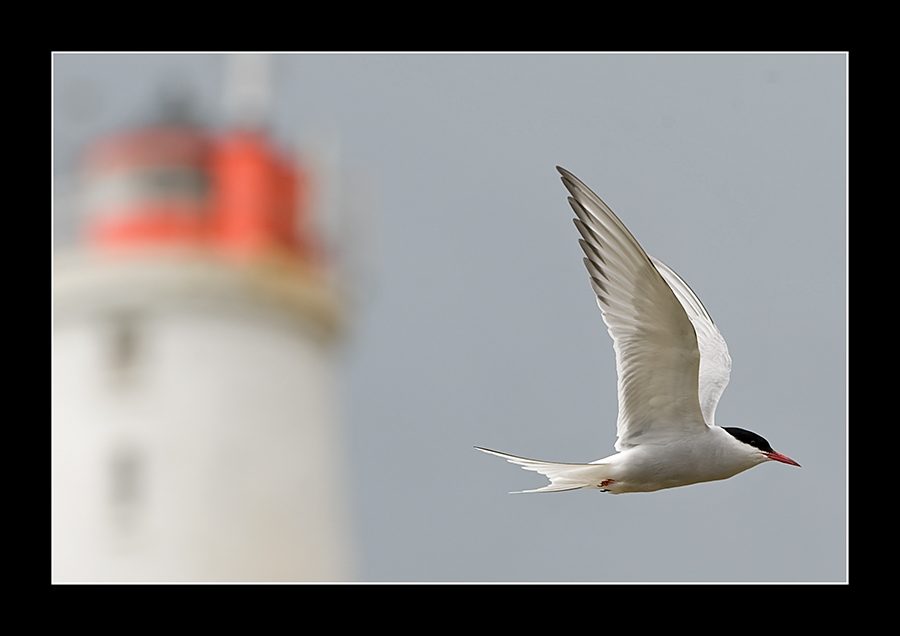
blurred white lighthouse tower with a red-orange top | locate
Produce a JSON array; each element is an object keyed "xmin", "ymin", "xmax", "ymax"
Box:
[{"xmin": 52, "ymin": 57, "xmax": 353, "ymax": 581}]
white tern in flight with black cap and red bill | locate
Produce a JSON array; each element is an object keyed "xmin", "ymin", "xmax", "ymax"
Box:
[{"xmin": 476, "ymin": 167, "xmax": 800, "ymax": 494}]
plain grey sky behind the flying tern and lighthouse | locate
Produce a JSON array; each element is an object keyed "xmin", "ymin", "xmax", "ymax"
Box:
[{"xmin": 53, "ymin": 54, "xmax": 847, "ymax": 582}]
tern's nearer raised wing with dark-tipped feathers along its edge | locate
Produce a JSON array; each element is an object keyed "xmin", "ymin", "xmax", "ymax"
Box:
[{"xmin": 557, "ymin": 167, "xmax": 712, "ymax": 451}]
